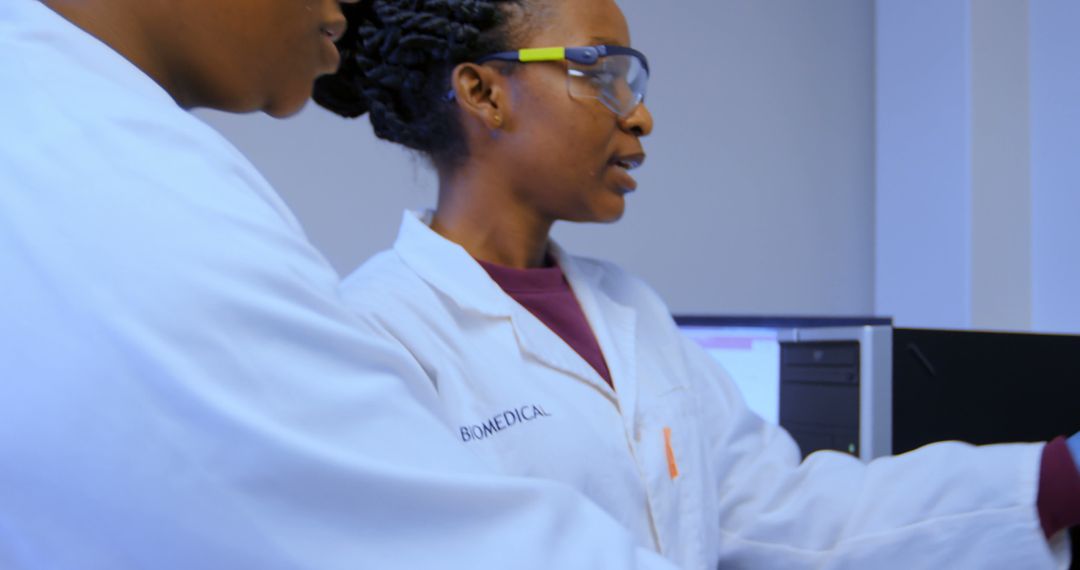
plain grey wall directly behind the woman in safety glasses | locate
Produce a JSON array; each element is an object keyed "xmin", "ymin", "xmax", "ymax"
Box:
[{"xmin": 201, "ymin": 0, "xmax": 874, "ymax": 314}]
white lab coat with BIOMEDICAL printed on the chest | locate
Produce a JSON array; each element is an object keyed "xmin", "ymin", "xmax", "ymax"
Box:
[{"xmin": 342, "ymin": 214, "xmax": 1068, "ymax": 570}]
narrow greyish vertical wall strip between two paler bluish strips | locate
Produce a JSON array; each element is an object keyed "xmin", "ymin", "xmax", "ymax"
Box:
[{"xmin": 970, "ymin": 0, "xmax": 1028, "ymax": 330}]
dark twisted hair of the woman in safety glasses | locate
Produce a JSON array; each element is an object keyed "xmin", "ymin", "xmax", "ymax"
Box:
[{"xmin": 314, "ymin": 0, "xmax": 536, "ymax": 163}]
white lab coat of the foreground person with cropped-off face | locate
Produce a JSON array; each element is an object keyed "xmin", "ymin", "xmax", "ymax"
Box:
[{"xmin": 0, "ymin": 0, "xmax": 670, "ymax": 570}]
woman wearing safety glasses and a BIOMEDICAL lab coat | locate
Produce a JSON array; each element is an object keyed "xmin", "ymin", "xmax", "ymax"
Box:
[{"xmin": 315, "ymin": 0, "xmax": 1068, "ymax": 569}]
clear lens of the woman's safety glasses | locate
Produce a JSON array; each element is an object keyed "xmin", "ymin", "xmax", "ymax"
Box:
[{"xmin": 567, "ymin": 54, "xmax": 649, "ymax": 118}]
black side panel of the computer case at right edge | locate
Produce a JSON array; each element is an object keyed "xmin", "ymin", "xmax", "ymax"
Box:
[{"xmin": 893, "ymin": 328, "xmax": 1080, "ymax": 453}]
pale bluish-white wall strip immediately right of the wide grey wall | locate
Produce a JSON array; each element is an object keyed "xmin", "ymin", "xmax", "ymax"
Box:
[{"xmin": 875, "ymin": 0, "xmax": 971, "ymax": 327}]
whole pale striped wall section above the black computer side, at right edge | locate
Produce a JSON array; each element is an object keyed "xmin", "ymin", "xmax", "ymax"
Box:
[{"xmin": 875, "ymin": 0, "xmax": 1080, "ymax": 333}]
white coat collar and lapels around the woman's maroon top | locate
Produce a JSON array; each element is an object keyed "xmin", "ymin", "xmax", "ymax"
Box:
[{"xmin": 394, "ymin": 212, "xmax": 619, "ymax": 401}]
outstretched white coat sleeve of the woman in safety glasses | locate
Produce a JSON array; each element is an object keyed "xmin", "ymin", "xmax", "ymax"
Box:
[{"xmin": 675, "ymin": 333, "xmax": 1068, "ymax": 569}]
